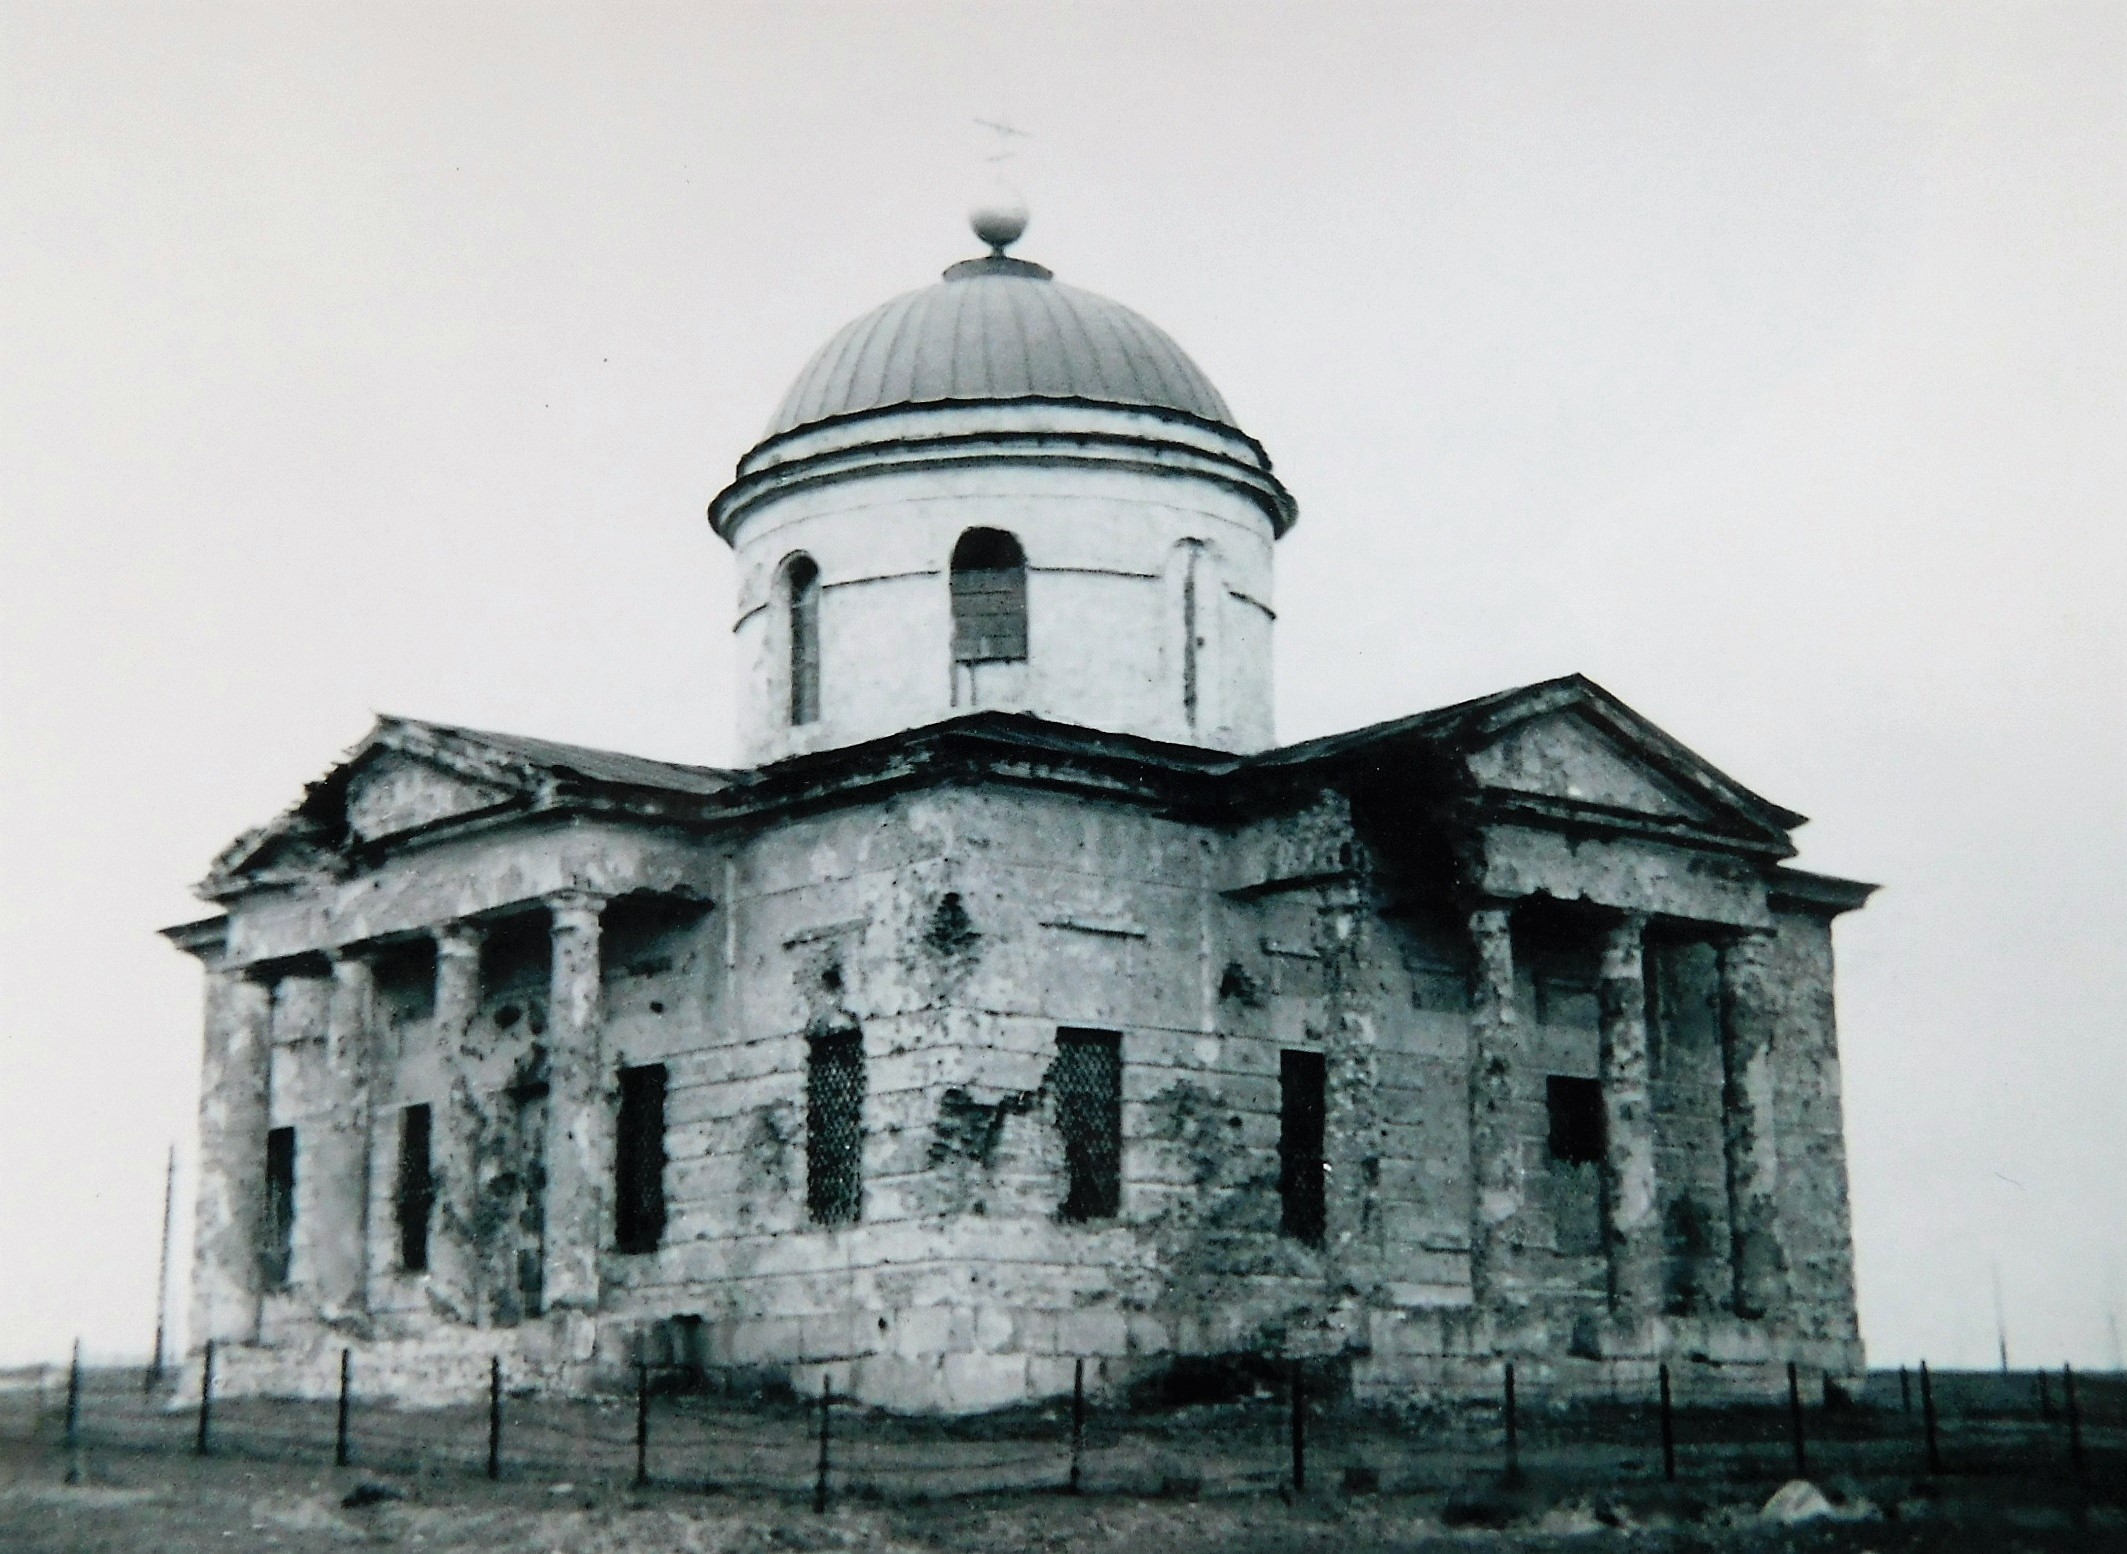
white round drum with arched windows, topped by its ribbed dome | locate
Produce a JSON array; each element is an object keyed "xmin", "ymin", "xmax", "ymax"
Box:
[{"xmin": 708, "ymin": 225, "xmax": 1295, "ymax": 761}]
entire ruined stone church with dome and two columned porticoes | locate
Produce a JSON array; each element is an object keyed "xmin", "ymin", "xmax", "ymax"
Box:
[{"xmin": 168, "ymin": 213, "xmax": 1872, "ymax": 1412}]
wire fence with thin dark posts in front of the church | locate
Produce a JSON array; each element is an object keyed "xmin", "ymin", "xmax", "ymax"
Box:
[{"xmin": 0, "ymin": 1354, "xmax": 2127, "ymax": 1507}]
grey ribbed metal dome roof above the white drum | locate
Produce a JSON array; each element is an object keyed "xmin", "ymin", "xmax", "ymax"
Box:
[{"xmin": 766, "ymin": 255, "xmax": 1234, "ymax": 438}]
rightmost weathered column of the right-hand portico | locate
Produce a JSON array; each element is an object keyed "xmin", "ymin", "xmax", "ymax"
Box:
[{"xmin": 1721, "ymin": 933, "xmax": 1787, "ymax": 1318}]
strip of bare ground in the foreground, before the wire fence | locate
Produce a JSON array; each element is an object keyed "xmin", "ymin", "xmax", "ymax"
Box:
[{"xmin": 0, "ymin": 1441, "xmax": 2127, "ymax": 1554}]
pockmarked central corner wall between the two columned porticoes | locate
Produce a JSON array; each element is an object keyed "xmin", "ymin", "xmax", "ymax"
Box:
[{"xmin": 630, "ymin": 789, "xmax": 1531, "ymax": 1407}]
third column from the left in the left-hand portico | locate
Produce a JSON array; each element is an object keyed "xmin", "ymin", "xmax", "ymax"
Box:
[{"xmin": 431, "ymin": 923, "xmax": 487, "ymax": 1322}]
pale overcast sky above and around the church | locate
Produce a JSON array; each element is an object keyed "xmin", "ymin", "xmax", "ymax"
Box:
[{"xmin": 0, "ymin": 0, "xmax": 2127, "ymax": 1365}]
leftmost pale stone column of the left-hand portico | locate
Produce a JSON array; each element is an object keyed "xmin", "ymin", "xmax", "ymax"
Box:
[{"xmin": 191, "ymin": 969, "xmax": 272, "ymax": 1346}]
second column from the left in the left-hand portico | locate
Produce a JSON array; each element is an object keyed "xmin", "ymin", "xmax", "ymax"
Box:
[{"xmin": 298, "ymin": 952, "xmax": 376, "ymax": 1316}]
